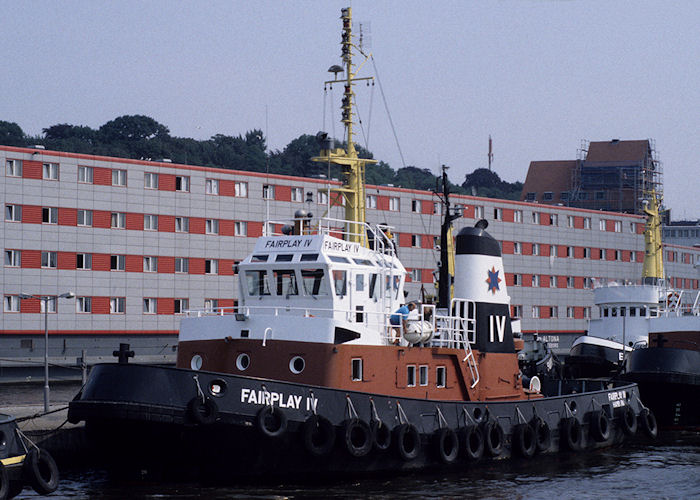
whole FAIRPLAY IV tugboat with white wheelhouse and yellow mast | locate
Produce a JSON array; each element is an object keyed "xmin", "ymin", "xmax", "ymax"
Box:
[{"xmin": 68, "ymin": 8, "xmax": 657, "ymax": 480}]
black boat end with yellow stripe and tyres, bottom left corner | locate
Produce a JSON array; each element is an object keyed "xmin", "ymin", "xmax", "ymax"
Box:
[{"xmin": 0, "ymin": 413, "xmax": 58, "ymax": 500}]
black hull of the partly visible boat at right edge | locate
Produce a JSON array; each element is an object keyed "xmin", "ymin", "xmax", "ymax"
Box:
[{"xmin": 622, "ymin": 347, "xmax": 700, "ymax": 429}]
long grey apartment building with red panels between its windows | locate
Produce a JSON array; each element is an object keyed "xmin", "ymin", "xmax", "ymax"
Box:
[{"xmin": 0, "ymin": 146, "xmax": 700, "ymax": 376}]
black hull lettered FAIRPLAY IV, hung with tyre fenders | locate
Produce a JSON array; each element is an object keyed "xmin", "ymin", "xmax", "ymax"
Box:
[{"xmin": 69, "ymin": 364, "xmax": 641, "ymax": 480}]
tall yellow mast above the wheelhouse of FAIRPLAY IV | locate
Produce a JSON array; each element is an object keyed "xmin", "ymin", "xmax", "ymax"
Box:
[{"xmin": 311, "ymin": 7, "xmax": 377, "ymax": 246}]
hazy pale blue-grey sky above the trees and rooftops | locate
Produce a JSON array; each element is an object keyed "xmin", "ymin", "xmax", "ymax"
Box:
[{"xmin": 0, "ymin": 0, "xmax": 700, "ymax": 219}]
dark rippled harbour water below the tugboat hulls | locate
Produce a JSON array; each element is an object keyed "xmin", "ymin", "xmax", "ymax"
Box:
[{"xmin": 5, "ymin": 386, "xmax": 700, "ymax": 500}]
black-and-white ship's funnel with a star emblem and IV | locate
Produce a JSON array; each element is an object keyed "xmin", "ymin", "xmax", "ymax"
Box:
[{"xmin": 452, "ymin": 224, "xmax": 514, "ymax": 352}]
